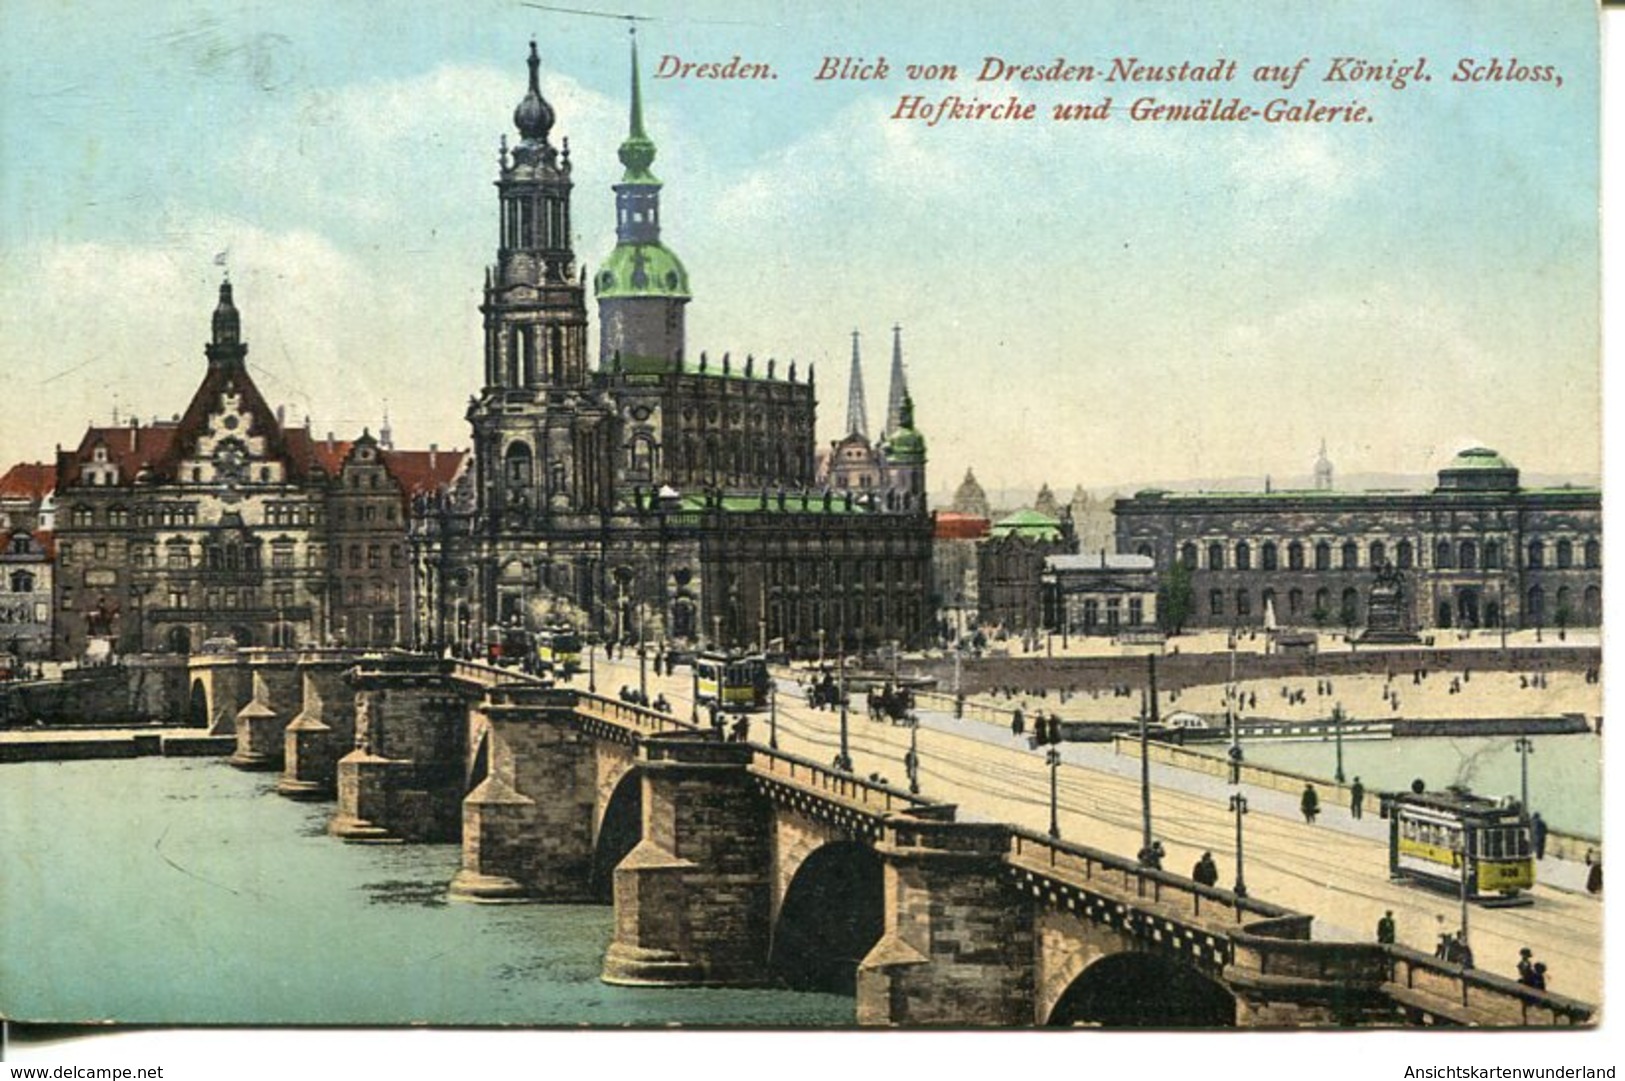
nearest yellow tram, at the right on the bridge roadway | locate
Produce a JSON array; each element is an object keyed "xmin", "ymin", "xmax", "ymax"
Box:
[{"xmin": 1385, "ymin": 788, "xmax": 1534, "ymax": 905}]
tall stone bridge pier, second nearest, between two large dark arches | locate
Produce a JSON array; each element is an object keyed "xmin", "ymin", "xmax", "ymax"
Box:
[{"xmin": 603, "ymin": 733, "xmax": 772, "ymax": 987}]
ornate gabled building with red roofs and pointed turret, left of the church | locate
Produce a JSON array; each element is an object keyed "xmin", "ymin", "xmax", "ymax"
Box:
[{"xmin": 54, "ymin": 283, "xmax": 460, "ymax": 658}]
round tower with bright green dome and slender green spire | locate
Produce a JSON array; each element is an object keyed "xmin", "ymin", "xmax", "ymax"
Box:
[{"xmin": 593, "ymin": 37, "xmax": 691, "ymax": 372}]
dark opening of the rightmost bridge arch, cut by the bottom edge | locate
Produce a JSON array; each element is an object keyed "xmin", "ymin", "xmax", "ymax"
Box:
[{"xmin": 1045, "ymin": 951, "xmax": 1235, "ymax": 1029}]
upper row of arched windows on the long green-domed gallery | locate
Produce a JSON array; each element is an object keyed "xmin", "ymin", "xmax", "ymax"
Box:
[{"xmin": 1176, "ymin": 538, "xmax": 1602, "ymax": 571}]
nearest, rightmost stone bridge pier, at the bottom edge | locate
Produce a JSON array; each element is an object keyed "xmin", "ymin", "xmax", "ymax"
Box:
[{"xmin": 858, "ymin": 814, "xmax": 1034, "ymax": 1027}]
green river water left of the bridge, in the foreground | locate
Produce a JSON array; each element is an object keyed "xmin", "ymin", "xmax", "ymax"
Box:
[{"xmin": 0, "ymin": 759, "xmax": 853, "ymax": 1027}]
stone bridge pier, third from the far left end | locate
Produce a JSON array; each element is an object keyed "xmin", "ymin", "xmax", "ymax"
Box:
[{"xmin": 328, "ymin": 658, "xmax": 468, "ymax": 844}]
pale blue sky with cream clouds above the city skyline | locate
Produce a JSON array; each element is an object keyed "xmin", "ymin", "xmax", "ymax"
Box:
[{"xmin": 0, "ymin": 0, "xmax": 1599, "ymax": 491}]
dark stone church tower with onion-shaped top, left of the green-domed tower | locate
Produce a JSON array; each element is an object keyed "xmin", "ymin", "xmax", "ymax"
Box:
[{"xmin": 479, "ymin": 42, "xmax": 587, "ymax": 395}]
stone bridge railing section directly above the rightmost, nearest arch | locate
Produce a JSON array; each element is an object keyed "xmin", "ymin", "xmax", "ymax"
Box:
[{"xmin": 1011, "ymin": 826, "xmax": 1315, "ymax": 938}]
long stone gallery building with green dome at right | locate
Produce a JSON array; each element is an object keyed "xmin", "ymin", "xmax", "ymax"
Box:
[{"xmin": 1115, "ymin": 447, "xmax": 1602, "ymax": 629}]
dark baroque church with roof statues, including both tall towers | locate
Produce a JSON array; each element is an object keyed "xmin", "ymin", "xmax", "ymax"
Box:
[{"xmin": 413, "ymin": 42, "xmax": 931, "ymax": 655}]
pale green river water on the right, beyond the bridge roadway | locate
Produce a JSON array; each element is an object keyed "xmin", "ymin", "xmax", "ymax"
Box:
[{"xmin": 1191, "ymin": 733, "xmax": 1602, "ymax": 837}]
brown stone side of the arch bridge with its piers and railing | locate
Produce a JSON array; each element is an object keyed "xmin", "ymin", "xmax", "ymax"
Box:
[{"xmin": 187, "ymin": 650, "xmax": 1593, "ymax": 1027}]
